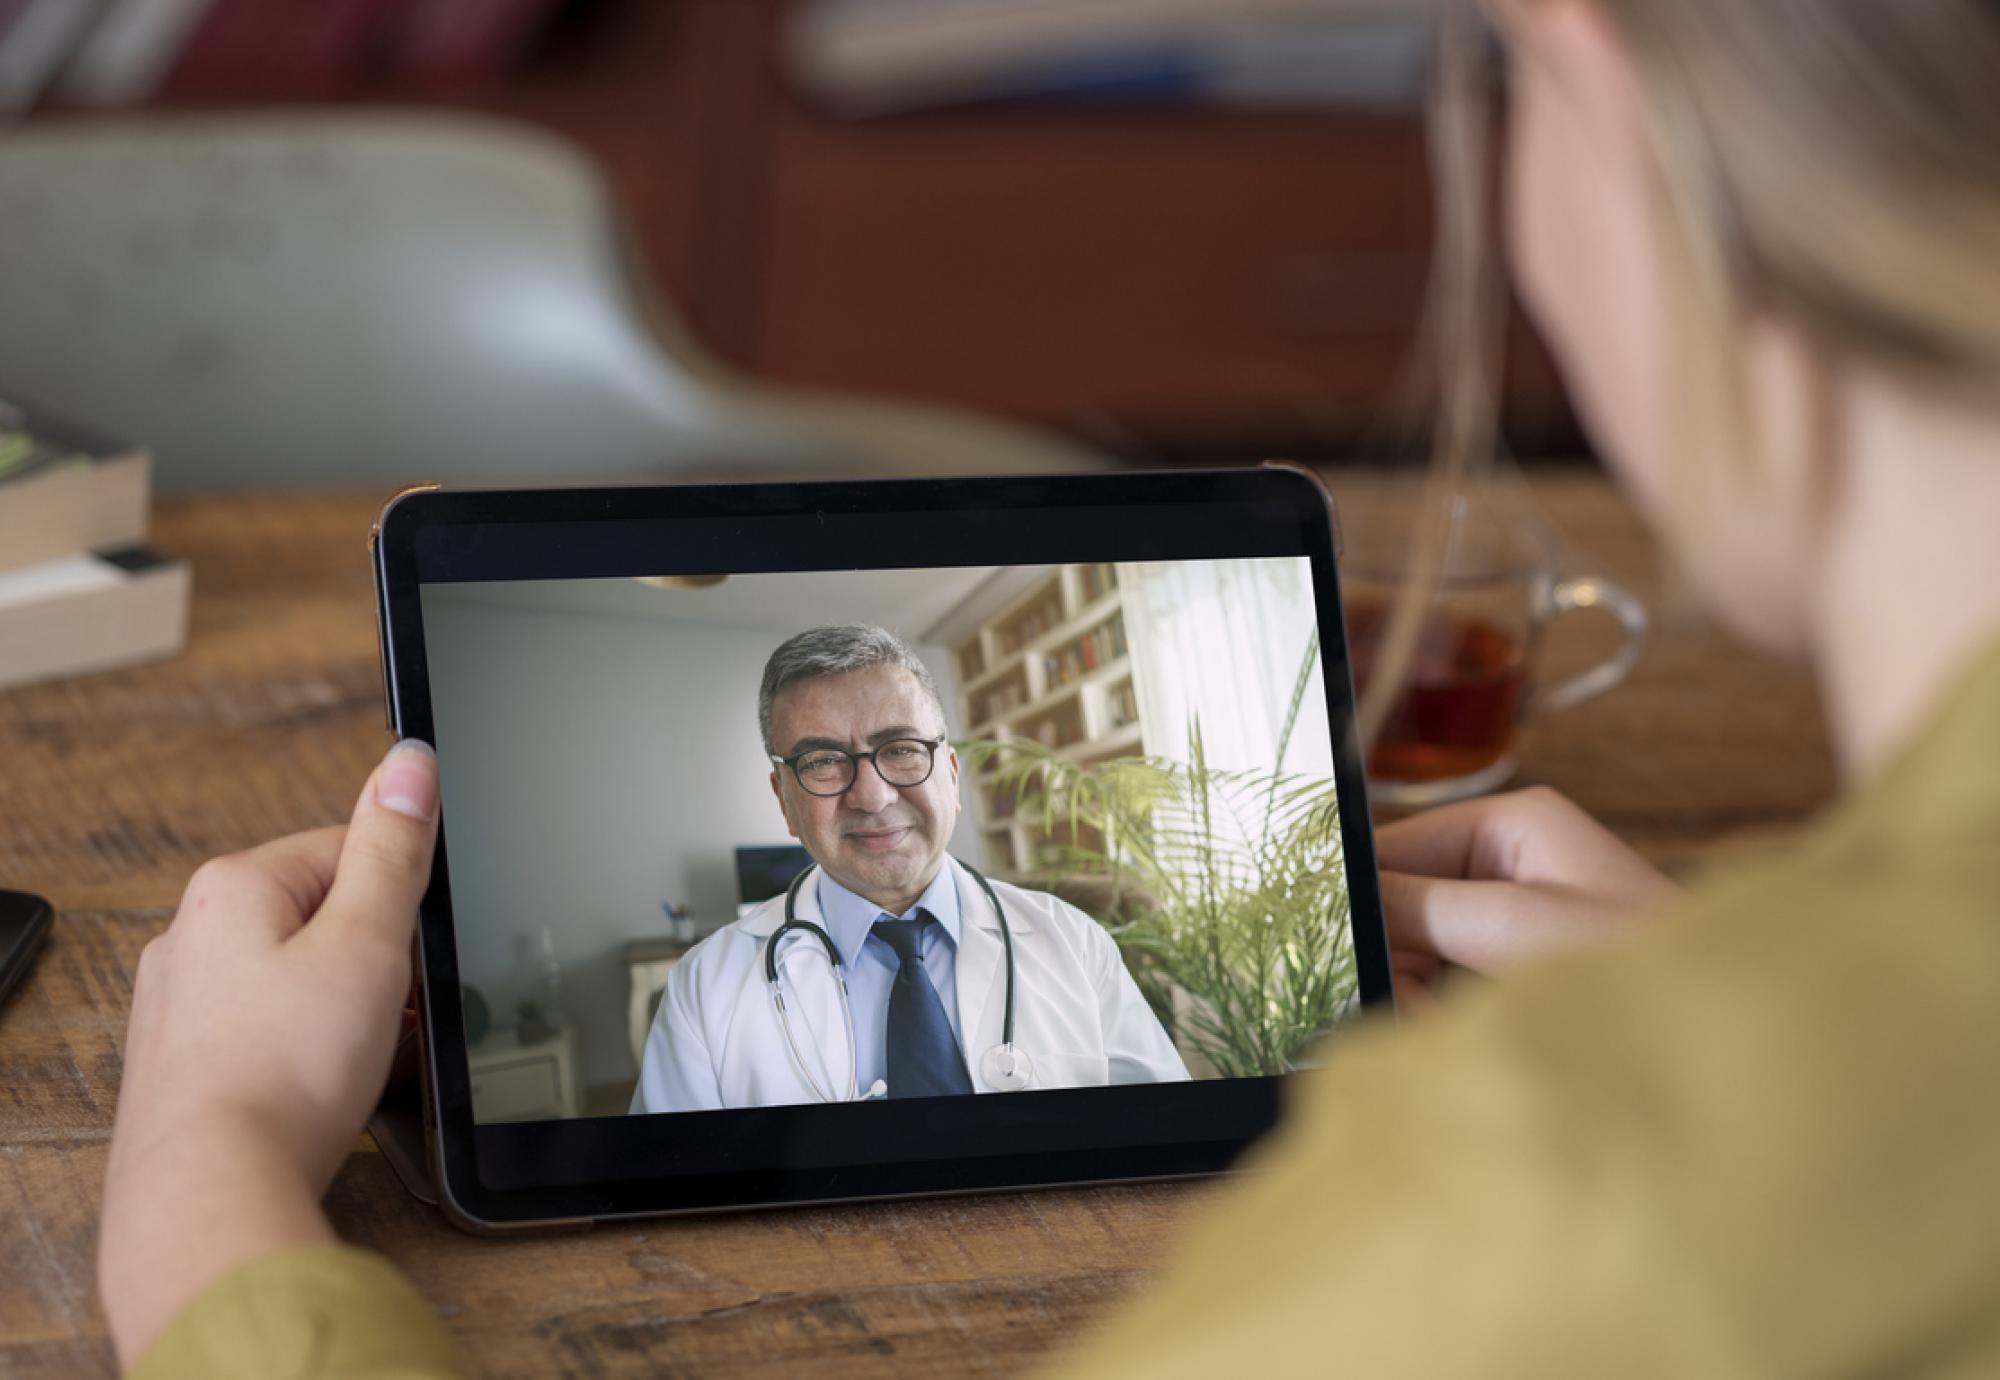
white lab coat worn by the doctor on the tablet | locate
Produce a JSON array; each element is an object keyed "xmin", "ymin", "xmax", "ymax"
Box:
[{"xmin": 632, "ymin": 858, "xmax": 1188, "ymax": 1112}]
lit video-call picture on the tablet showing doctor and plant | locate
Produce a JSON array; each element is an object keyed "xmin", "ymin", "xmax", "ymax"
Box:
[{"xmin": 422, "ymin": 556, "xmax": 1358, "ymax": 1124}]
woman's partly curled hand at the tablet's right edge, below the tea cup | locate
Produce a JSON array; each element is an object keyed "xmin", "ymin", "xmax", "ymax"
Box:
[{"xmin": 1376, "ymin": 786, "xmax": 1678, "ymax": 1002}]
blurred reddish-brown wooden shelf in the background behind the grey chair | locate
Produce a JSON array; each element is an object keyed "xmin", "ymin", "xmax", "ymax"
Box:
[{"xmin": 0, "ymin": 0, "xmax": 1576, "ymax": 460}]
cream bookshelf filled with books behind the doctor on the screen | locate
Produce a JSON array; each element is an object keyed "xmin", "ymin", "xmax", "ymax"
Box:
[{"xmin": 952, "ymin": 562, "xmax": 1144, "ymax": 878}]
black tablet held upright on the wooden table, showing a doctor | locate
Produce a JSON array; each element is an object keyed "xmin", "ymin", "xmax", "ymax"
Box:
[{"xmin": 372, "ymin": 468, "xmax": 1390, "ymax": 1230}]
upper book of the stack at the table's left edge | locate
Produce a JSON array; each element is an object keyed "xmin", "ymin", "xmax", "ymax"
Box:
[{"xmin": 0, "ymin": 398, "xmax": 152, "ymax": 570}]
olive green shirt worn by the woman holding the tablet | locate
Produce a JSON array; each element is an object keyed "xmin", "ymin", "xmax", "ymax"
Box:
[{"xmin": 134, "ymin": 650, "xmax": 2000, "ymax": 1380}]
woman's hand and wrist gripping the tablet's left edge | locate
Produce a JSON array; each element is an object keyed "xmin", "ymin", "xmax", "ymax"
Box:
[{"xmin": 98, "ymin": 742, "xmax": 438, "ymax": 1364}]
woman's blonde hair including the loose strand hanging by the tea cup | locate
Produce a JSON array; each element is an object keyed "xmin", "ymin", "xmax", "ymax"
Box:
[{"xmin": 1360, "ymin": 0, "xmax": 2000, "ymax": 742}]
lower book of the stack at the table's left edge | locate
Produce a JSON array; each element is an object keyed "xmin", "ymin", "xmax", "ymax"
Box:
[{"xmin": 0, "ymin": 546, "xmax": 190, "ymax": 688}]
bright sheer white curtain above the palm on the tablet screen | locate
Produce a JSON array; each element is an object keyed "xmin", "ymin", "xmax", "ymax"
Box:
[{"xmin": 1118, "ymin": 556, "xmax": 1334, "ymax": 776}]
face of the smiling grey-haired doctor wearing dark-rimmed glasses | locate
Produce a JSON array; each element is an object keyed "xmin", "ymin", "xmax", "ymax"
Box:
[{"xmin": 770, "ymin": 666, "xmax": 958, "ymax": 914}]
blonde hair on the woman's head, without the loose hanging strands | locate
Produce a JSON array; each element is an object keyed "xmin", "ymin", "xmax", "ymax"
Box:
[{"xmin": 1608, "ymin": 0, "xmax": 2000, "ymax": 384}]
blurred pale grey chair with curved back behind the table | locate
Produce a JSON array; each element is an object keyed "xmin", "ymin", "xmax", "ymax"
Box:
[{"xmin": 0, "ymin": 112, "xmax": 1104, "ymax": 490}]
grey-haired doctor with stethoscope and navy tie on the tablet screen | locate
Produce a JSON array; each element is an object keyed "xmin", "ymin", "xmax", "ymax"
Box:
[{"xmin": 632, "ymin": 628, "xmax": 1188, "ymax": 1112}]
